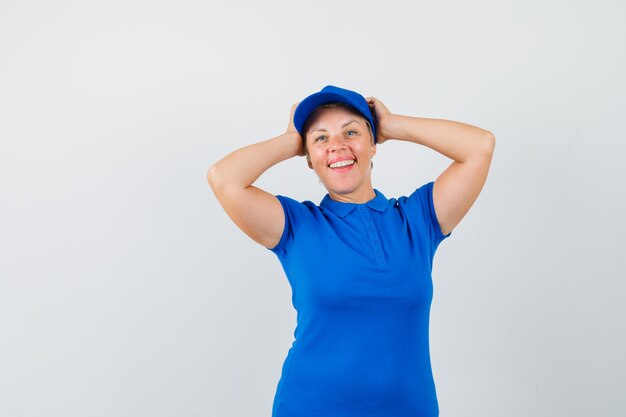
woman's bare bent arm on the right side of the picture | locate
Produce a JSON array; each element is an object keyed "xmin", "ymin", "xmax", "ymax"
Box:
[{"xmin": 367, "ymin": 97, "xmax": 496, "ymax": 235}]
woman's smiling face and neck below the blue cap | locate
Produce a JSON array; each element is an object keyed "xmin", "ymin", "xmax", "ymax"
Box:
[{"xmin": 306, "ymin": 107, "xmax": 376, "ymax": 203}]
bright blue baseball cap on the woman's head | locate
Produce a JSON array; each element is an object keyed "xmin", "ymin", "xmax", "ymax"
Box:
[{"xmin": 293, "ymin": 85, "xmax": 376, "ymax": 143}]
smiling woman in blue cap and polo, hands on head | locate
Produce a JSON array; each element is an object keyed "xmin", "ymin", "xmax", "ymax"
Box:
[{"xmin": 208, "ymin": 86, "xmax": 495, "ymax": 417}]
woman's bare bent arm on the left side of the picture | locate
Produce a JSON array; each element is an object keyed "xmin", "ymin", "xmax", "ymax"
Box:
[{"xmin": 207, "ymin": 103, "xmax": 304, "ymax": 248}]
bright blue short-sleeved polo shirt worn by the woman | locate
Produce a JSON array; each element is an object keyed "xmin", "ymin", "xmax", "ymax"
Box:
[{"xmin": 270, "ymin": 182, "xmax": 451, "ymax": 417}]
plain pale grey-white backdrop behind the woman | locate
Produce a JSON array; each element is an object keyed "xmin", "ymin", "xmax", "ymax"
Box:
[{"xmin": 0, "ymin": 0, "xmax": 626, "ymax": 417}]
